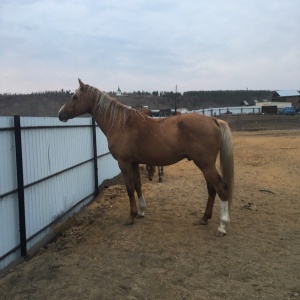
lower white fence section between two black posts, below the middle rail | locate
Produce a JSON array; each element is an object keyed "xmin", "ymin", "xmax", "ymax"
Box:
[{"xmin": 25, "ymin": 162, "xmax": 94, "ymax": 248}]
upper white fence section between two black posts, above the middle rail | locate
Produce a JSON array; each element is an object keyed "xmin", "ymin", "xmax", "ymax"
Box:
[{"xmin": 21, "ymin": 118, "xmax": 93, "ymax": 185}]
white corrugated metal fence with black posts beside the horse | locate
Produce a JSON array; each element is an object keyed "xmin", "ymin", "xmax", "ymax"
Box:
[{"xmin": 0, "ymin": 116, "xmax": 120, "ymax": 269}]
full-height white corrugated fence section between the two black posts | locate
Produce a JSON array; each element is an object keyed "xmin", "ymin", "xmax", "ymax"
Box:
[{"xmin": 21, "ymin": 118, "xmax": 94, "ymax": 248}]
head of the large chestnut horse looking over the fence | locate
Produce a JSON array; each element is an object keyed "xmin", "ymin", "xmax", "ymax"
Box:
[{"xmin": 58, "ymin": 79, "xmax": 90, "ymax": 122}]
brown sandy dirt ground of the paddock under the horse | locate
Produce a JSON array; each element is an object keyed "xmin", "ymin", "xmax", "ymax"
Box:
[{"xmin": 0, "ymin": 130, "xmax": 300, "ymax": 300}]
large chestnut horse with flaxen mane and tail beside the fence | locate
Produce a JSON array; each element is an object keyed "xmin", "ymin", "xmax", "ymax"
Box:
[{"xmin": 58, "ymin": 79, "xmax": 234, "ymax": 236}]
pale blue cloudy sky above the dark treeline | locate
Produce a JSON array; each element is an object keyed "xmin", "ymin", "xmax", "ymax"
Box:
[{"xmin": 0, "ymin": 0, "xmax": 300, "ymax": 93}]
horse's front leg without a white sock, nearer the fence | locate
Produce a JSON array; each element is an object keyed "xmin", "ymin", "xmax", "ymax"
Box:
[{"xmin": 118, "ymin": 161, "xmax": 138, "ymax": 225}]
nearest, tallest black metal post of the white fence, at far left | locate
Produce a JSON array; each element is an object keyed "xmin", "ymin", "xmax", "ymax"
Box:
[{"xmin": 14, "ymin": 116, "xmax": 27, "ymax": 256}]
